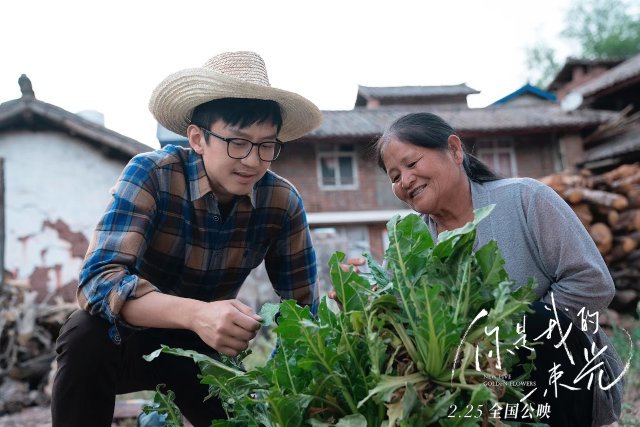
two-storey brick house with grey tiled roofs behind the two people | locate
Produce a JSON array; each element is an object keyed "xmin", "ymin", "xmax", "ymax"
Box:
[{"xmin": 158, "ymin": 84, "xmax": 614, "ymax": 273}]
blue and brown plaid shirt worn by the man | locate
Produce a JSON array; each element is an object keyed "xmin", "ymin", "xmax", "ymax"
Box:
[{"xmin": 78, "ymin": 146, "xmax": 318, "ymax": 324}]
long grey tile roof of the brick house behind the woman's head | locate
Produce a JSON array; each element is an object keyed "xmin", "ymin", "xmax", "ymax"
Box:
[{"xmin": 303, "ymin": 104, "xmax": 617, "ymax": 139}]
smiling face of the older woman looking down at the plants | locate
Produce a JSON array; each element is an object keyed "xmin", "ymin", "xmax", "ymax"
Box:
[{"xmin": 382, "ymin": 135, "xmax": 465, "ymax": 215}]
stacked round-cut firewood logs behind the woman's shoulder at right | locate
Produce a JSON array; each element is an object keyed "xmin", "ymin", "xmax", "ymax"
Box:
[{"xmin": 540, "ymin": 163, "xmax": 640, "ymax": 313}]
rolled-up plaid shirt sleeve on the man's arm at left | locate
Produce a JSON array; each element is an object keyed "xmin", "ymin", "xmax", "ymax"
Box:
[{"xmin": 77, "ymin": 156, "xmax": 157, "ymax": 323}]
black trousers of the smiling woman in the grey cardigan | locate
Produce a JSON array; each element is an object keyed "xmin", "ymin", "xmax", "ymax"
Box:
[{"xmin": 510, "ymin": 302, "xmax": 597, "ymax": 427}]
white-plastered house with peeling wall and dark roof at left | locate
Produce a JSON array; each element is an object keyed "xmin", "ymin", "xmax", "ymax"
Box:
[{"xmin": 0, "ymin": 76, "xmax": 151, "ymax": 301}]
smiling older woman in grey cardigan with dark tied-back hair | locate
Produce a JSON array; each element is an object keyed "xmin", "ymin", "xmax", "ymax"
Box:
[{"xmin": 375, "ymin": 113, "xmax": 622, "ymax": 426}]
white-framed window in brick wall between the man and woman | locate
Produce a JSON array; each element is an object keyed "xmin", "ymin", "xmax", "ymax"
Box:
[{"xmin": 317, "ymin": 144, "xmax": 358, "ymax": 190}]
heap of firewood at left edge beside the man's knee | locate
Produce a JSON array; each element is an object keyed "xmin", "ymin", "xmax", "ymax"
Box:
[{"xmin": 0, "ymin": 281, "xmax": 77, "ymax": 416}]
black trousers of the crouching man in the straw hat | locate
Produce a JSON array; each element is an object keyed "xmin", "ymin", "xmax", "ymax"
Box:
[{"xmin": 51, "ymin": 310, "xmax": 226, "ymax": 427}]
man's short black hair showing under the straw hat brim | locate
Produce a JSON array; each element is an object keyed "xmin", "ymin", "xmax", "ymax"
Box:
[{"xmin": 191, "ymin": 98, "xmax": 282, "ymax": 136}]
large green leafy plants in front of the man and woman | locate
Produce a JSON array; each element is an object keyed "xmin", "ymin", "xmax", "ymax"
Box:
[{"xmin": 148, "ymin": 206, "xmax": 534, "ymax": 427}]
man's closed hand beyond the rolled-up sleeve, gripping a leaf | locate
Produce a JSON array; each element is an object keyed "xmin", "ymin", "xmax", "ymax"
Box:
[{"xmin": 191, "ymin": 299, "xmax": 262, "ymax": 356}]
